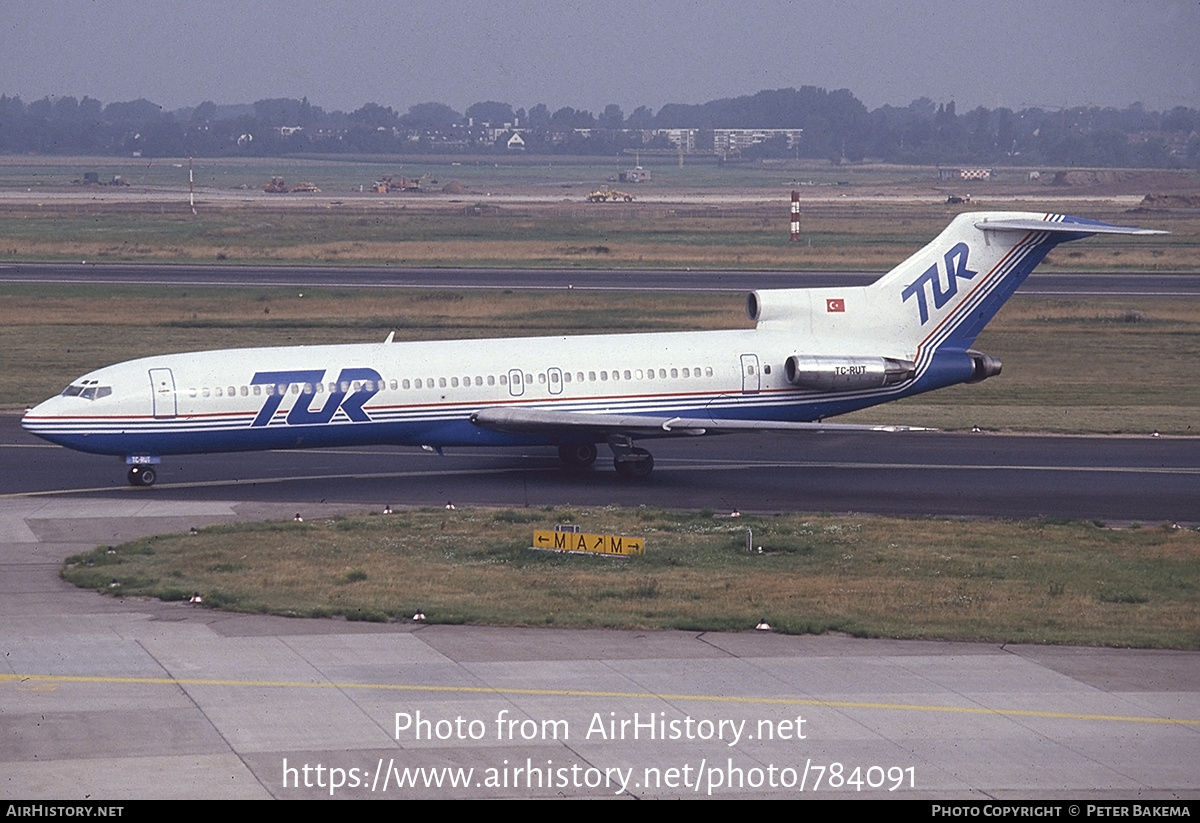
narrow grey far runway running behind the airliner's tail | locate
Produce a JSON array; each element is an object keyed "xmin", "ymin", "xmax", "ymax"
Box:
[{"xmin": 0, "ymin": 263, "xmax": 1200, "ymax": 298}]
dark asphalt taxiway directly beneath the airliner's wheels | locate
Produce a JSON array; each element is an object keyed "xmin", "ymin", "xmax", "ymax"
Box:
[{"xmin": 0, "ymin": 416, "xmax": 1200, "ymax": 523}]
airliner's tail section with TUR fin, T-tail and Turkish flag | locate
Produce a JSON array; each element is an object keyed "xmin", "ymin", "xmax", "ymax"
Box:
[{"xmin": 746, "ymin": 212, "xmax": 1163, "ymax": 405}]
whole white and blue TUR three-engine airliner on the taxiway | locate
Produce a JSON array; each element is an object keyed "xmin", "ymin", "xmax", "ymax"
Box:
[{"xmin": 22, "ymin": 212, "xmax": 1163, "ymax": 486}]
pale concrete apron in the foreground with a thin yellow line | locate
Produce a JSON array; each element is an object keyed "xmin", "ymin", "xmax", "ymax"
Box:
[{"xmin": 0, "ymin": 487, "xmax": 1200, "ymax": 801}]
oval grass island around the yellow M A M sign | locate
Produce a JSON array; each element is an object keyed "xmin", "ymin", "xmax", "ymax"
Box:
[{"xmin": 62, "ymin": 507, "xmax": 1200, "ymax": 649}]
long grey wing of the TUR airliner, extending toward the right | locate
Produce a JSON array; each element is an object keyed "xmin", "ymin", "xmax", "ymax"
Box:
[{"xmin": 470, "ymin": 409, "xmax": 934, "ymax": 437}]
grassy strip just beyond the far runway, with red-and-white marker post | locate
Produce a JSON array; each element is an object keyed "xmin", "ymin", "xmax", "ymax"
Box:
[{"xmin": 0, "ymin": 195, "xmax": 1200, "ymax": 267}]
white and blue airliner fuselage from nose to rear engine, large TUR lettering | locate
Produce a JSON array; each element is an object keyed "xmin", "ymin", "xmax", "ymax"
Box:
[{"xmin": 24, "ymin": 330, "xmax": 895, "ymax": 455}]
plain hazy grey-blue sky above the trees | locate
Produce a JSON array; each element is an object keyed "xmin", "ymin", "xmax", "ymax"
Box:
[{"xmin": 0, "ymin": 0, "xmax": 1200, "ymax": 115}]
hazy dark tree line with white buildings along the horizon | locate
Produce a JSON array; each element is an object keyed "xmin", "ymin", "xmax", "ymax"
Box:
[{"xmin": 0, "ymin": 86, "xmax": 1200, "ymax": 168}]
